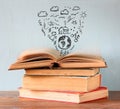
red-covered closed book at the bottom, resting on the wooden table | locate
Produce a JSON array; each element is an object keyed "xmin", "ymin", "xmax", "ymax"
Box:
[{"xmin": 19, "ymin": 87, "xmax": 108, "ymax": 103}]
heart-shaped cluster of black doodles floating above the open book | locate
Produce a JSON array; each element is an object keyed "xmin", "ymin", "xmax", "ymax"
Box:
[{"xmin": 38, "ymin": 6, "xmax": 87, "ymax": 55}]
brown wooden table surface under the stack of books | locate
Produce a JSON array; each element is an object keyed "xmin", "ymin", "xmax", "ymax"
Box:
[{"xmin": 0, "ymin": 91, "xmax": 120, "ymax": 109}]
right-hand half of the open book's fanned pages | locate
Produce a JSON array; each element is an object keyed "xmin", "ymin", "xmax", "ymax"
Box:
[{"xmin": 58, "ymin": 53, "xmax": 107, "ymax": 68}]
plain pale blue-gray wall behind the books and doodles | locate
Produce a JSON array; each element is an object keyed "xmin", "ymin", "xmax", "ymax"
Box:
[{"xmin": 0, "ymin": 0, "xmax": 120, "ymax": 90}]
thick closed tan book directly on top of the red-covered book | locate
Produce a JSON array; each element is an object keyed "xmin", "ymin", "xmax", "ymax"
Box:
[{"xmin": 22, "ymin": 73, "xmax": 101, "ymax": 92}]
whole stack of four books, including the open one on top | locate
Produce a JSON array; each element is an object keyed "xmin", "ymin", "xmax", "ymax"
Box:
[{"xmin": 9, "ymin": 49, "xmax": 108, "ymax": 103}]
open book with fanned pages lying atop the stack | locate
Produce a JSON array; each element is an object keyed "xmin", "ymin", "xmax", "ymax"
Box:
[{"xmin": 9, "ymin": 49, "xmax": 106, "ymax": 70}]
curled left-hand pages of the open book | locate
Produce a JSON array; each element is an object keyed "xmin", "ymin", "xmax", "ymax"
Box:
[{"xmin": 17, "ymin": 48, "xmax": 60, "ymax": 62}]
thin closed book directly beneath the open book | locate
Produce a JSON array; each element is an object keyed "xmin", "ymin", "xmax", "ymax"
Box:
[{"xmin": 25, "ymin": 68, "xmax": 100, "ymax": 76}]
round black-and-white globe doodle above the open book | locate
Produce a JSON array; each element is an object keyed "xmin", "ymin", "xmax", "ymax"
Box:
[{"xmin": 58, "ymin": 36, "xmax": 71, "ymax": 50}]
